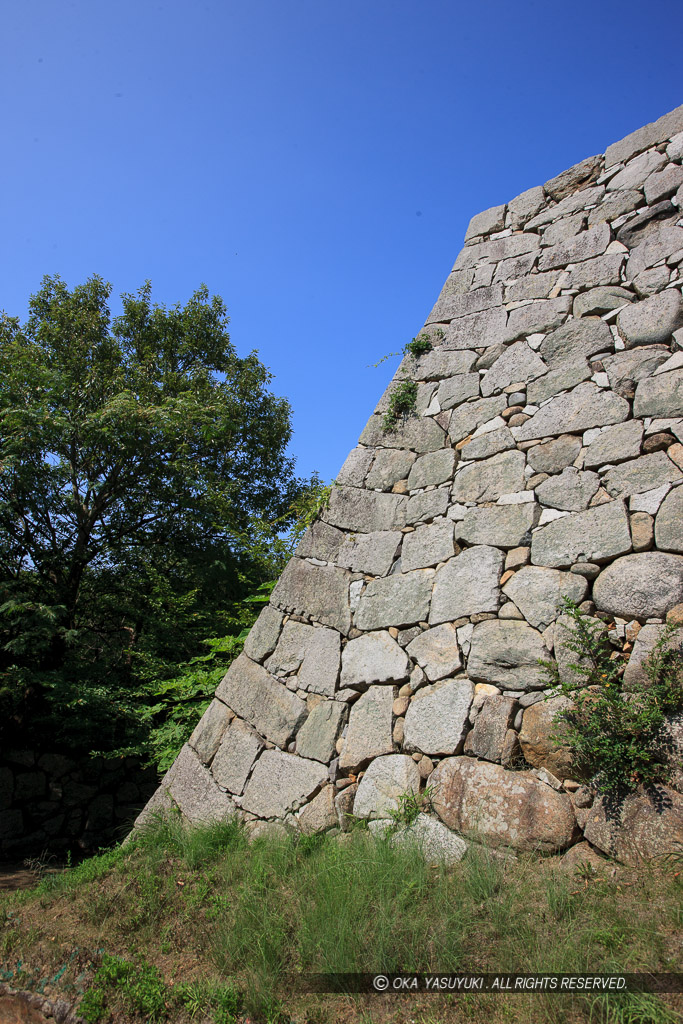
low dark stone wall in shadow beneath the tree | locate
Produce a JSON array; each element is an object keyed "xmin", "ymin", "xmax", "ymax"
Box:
[{"xmin": 0, "ymin": 750, "xmax": 157, "ymax": 859}]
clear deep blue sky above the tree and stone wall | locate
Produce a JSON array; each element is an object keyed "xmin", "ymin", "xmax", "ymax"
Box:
[{"xmin": 0, "ymin": 0, "xmax": 683, "ymax": 479}]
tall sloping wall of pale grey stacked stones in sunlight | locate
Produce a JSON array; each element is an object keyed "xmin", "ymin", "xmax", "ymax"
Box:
[{"xmin": 137, "ymin": 106, "xmax": 683, "ymax": 857}]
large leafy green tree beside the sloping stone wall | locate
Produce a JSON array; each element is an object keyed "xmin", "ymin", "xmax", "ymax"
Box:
[{"xmin": 0, "ymin": 276, "xmax": 310, "ymax": 749}]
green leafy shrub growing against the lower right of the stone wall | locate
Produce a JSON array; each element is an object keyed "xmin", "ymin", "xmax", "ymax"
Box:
[{"xmin": 551, "ymin": 600, "xmax": 683, "ymax": 797}]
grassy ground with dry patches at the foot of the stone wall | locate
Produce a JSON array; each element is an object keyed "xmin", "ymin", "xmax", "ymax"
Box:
[{"xmin": 0, "ymin": 819, "xmax": 683, "ymax": 1024}]
